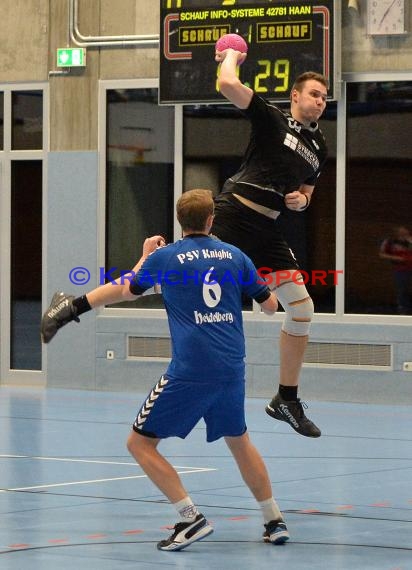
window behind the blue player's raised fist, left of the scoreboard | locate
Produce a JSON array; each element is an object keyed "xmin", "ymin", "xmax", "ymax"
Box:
[{"xmin": 105, "ymin": 88, "xmax": 175, "ymax": 308}]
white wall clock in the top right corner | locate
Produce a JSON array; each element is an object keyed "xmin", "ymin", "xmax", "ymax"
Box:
[{"xmin": 367, "ymin": 0, "xmax": 406, "ymax": 36}]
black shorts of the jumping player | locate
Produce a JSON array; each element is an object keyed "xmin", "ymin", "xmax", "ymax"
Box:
[{"xmin": 212, "ymin": 194, "xmax": 299, "ymax": 271}]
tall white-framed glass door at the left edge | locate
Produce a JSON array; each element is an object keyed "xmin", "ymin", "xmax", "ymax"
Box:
[{"xmin": 0, "ymin": 83, "xmax": 48, "ymax": 374}]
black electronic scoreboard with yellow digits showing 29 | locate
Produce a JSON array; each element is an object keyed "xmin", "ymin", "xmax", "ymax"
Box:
[{"xmin": 159, "ymin": 0, "xmax": 336, "ymax": 104}]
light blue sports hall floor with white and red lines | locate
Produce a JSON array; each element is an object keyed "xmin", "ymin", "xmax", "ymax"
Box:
[{"xmin": 0, "ymin": 387, "xmax": 412, "ymax": 570}]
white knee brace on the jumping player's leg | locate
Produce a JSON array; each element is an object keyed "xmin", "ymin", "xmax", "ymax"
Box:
[{"xmin": 276, "ymin": 280, "xmax": 314, "ymax": 336}]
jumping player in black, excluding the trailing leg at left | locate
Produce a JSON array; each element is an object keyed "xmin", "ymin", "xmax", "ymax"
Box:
[{"xmin": 212, "ymin": 48, "xmax": 328, "ymax": 437}]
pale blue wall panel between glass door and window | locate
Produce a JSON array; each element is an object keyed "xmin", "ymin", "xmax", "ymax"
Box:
[{"xmin": 46, "ymin": 152, "xmax": 99, "ymax": 389}]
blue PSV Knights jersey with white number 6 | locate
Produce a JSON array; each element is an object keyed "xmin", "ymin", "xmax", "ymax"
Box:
[{"xmin": 130, "ymin": 234, "xmax": 270, "ymax": 382}]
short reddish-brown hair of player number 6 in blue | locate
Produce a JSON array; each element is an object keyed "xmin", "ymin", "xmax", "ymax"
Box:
[{"xmin": 176, "ymin": 188, "xmax": 214, "ymax": 232}]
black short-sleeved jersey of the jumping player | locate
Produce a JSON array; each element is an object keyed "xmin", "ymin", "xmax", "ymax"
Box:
[{"xmin": 222, "ymin": 93, "xmax": 327, "ymax": 211}]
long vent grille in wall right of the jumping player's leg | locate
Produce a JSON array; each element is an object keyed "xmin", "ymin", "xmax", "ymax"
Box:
[{"xmin": 304, "ymin": 342, "xmax": 392, "ymax": 368}]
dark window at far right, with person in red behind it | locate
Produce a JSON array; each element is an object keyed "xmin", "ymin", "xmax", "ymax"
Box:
[{"xmin": 345, "ymin": 82, "xmax": 412, "ymax": 314}]
